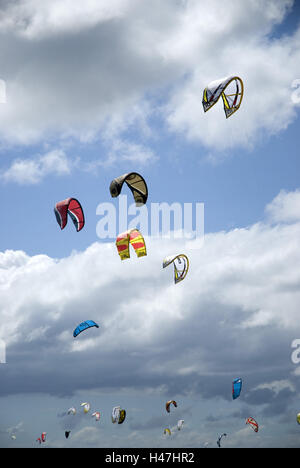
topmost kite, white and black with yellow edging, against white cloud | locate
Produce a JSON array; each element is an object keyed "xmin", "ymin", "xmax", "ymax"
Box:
[{"xmin": 202, "ymin": 76, "xmax": 244, "ymax": 119}]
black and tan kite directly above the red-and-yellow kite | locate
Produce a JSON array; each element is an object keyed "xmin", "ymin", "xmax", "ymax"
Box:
[{"xmin": 109, "ymin": 172, "xmax": 148, "ymax": 206}]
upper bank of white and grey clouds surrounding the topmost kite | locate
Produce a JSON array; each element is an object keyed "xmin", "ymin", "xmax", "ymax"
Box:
[{"xmin": 0, "ymin": 0, "xmax": 300, "ymax": 160}]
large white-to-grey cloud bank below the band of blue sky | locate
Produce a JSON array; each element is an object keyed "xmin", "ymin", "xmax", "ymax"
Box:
[{"xmin": 0, "ymin": 189, "xmax": 300, "ymax": 446}]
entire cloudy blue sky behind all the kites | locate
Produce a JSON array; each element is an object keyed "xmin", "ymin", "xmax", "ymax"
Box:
[{"xmin": 0, "ymin": 0, "xmax": 300, "ymax": 448}]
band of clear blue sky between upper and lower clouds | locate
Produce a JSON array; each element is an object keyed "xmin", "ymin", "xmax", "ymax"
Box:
[{"xmin": 1, "ymin": 114, "xmax": 299, "ymax": 257}]
